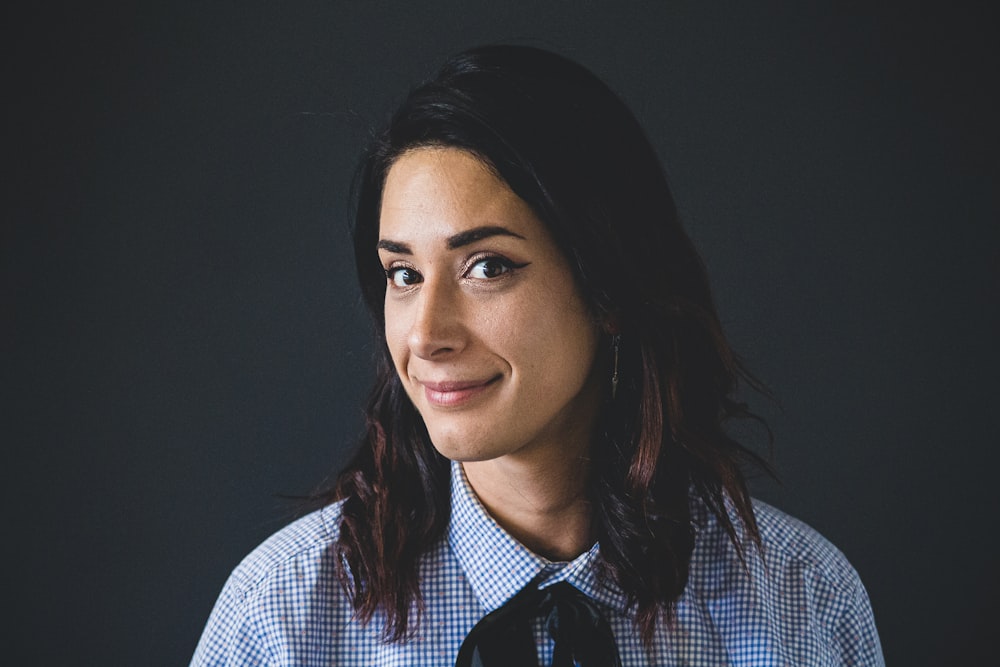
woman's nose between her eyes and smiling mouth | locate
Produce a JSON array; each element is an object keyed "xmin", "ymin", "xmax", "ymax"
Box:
[{"xmin": 409, "ymin": 281, "xmax": 465, "ymax": 359}]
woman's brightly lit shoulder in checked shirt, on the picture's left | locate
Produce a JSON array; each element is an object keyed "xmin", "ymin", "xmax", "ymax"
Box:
[{"xmin": 191, "ymin": 504, "xmax": 350, "ymax": 666}]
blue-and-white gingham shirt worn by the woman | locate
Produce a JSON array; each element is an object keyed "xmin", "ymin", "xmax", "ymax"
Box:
[{"xmin": 191, "ymin": 464, "xmax": 885, "ymax": 667}]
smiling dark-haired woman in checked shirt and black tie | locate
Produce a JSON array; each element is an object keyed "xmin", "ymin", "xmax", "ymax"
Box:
[{"xmin": 193, "ymin": 46, "xmax": 883, "ymax": 666}]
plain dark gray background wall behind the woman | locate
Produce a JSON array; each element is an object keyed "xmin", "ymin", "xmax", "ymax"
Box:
[{"xmin": 0, "ymin": 0, "xmax": 1000, "ymax": 665}]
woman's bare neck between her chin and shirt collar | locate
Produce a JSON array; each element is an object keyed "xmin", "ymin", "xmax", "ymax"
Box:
[{"xmin": 462, "ymin": 456, "xmax": 594, "ymax": 561}]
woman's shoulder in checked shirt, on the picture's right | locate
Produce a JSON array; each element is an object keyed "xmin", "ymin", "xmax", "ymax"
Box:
[{"xmin": 689, "ymin": 500, "xmax": 884, "ymax": 665}]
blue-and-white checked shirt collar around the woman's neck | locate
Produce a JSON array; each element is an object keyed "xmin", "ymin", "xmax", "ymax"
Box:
[{"xmin": 448, "ymin": 461, "xmax": 626, "ymax": 613}]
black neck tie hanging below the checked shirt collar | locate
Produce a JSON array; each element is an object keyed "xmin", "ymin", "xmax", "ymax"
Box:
[{"xmin": 455, "ymin": 581, "xmax": 621, "ymax": 667}]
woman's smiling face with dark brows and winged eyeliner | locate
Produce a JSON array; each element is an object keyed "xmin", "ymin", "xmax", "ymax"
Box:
[{"xmin": 378, "ymin": 148, "xmax": 603, "ymax": 468}]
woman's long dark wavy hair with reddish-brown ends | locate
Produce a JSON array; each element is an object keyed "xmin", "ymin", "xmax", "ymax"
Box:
[{"xmin": 324, "ymin": 46, "xmax": 767, "ymax": 641}]
